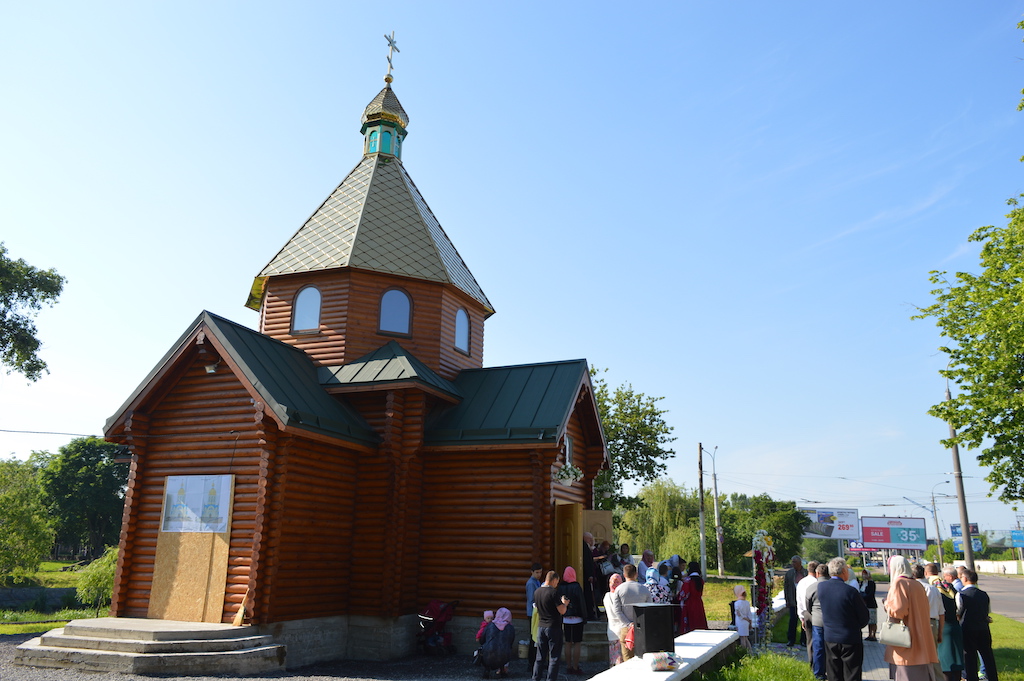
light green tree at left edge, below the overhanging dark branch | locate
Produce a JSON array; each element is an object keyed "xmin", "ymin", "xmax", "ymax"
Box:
[{"xmin": 0, "ymin": 459, "xmax": 53, "ymax": 578}]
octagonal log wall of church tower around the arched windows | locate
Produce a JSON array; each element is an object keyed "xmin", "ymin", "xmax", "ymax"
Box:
[{"xmin": 260, "ymin": 268, "xmax": 484, "ymax": 379}]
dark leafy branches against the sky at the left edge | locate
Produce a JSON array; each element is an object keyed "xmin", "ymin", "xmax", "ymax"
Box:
[{"xmin": 0, "ymin": 243, "xmax": 65, "ymax": 381}]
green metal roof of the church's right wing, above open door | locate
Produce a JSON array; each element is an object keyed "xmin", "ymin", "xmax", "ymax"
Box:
[{"xmin": 425, "ymin": 359, "xmax": 590, "ymax": 445}]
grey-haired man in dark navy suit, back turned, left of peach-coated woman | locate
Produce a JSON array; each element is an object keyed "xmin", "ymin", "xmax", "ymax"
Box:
[{"xmin": 817, "ymin": 558, "xmax": 868, "ymax": 681}]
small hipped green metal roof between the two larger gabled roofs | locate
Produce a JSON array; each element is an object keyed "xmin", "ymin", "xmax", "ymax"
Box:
[{"xmin": 316, "ymin": 341, "xmax": 462, "ymax": 399}]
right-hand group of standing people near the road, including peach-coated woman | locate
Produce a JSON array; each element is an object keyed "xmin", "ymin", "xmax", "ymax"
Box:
[{"xmin": 783, "ymin": 555, "xmax": 998, "ymax": 681}]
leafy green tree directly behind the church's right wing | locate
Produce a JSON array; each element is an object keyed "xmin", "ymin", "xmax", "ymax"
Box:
[{"xmin": 590, "ymin": 368, "xmax": 676, "ymax": 510}]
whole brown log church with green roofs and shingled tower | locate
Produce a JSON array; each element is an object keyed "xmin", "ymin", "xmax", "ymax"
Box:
[{"xmin": 105, "ymin": 67, "xmax": 613, "ymax": 666}]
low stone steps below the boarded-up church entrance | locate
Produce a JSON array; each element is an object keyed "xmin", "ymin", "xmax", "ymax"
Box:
[{"xmin": 14, "ymin": 618, "xmax": 285, "ymax": 676}]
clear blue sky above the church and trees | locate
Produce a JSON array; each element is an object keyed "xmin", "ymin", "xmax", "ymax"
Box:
[{"xmin": 0, "ymin": 0, "xmax": 1024, "ymax": 536}]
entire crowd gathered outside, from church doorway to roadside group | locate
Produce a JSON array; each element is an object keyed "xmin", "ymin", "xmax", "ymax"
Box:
[{"xmin": 485, "ymin": 536, "xmax": 998, "ymax": 681}]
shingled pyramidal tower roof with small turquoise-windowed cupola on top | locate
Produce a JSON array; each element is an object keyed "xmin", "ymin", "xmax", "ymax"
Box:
[{"xmin": 250, "ymin": 83, "xmax": 494, "ymax": 312}]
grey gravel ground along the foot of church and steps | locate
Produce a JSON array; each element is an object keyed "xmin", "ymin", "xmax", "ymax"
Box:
[{"xmin": 0, "ymin": 634, "xmax": 605, "ymax": 681}]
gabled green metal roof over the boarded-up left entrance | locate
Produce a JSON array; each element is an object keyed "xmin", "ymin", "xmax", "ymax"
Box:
[{"xmin": 104, "ymin": 311, "xmax": 380, "ymax": 444}]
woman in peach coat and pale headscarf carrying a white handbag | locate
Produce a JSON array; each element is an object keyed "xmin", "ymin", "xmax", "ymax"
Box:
[{"xmin": 883, "ymin": 556, "xmax": 939, "ymax": 681}]
